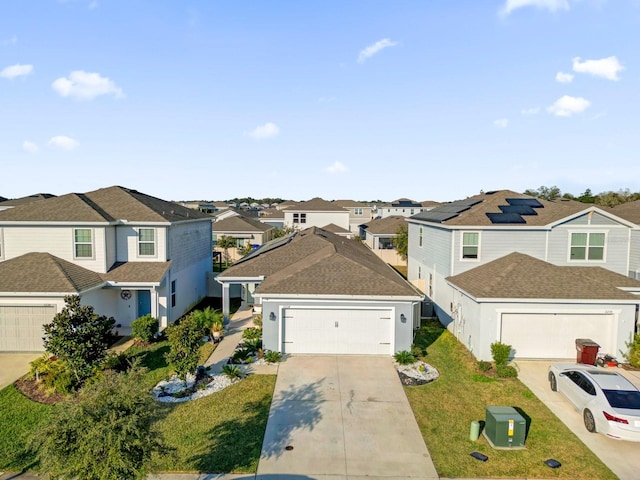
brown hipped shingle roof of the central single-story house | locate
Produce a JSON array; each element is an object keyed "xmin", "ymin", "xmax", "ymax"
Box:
[{"xmin": 219, "ymin": 227, "xmax": 422, "ymax": 298}]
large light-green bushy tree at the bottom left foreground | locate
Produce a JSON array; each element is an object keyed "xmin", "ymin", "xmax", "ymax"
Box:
[{"xmin": 31, "ymin": 366, "xmax": 168, "ymax": 480}]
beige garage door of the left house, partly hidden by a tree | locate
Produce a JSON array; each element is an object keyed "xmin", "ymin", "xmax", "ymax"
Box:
[{"xmin": 0, "ymin": 305, "xmax": 56, "ymax": 352}]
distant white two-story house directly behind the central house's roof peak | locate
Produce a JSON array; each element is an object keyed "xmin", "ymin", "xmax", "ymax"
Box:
[{"xmin": 283, "ymin": 197, "xmax": 350, "ymax": 230}]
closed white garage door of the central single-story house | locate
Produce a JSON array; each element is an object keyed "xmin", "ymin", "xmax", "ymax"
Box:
[{"xmin": 282, "ymin": 308, "xmax": 393, "ymax": 355}]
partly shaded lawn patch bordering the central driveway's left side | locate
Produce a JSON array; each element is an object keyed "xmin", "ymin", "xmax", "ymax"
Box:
[{"xmin": 155, "ymin": 375, "xmax": 276, "ymax": 473}]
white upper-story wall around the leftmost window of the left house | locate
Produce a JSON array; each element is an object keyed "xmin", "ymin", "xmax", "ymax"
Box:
[{"xmin": 2, "ymin": 225, "xmax": 111, "ymax": 273}]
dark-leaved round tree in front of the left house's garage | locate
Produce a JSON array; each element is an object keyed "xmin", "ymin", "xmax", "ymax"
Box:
[{"xmin": 43, "ymin": 295, "xmax": 116, "ymax": 382}]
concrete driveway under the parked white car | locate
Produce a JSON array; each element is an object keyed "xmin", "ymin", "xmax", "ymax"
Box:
[{"xmin": 516, "ymin": 361, "xmax": 640, "ymax": 480}]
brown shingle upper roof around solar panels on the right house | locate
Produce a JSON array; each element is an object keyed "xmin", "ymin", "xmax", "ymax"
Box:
[{"xmin": 411, "ymin": 190, "xmax": 590, "ymax": 226}]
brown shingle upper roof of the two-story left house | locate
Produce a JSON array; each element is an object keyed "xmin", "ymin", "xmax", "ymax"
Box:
[{"xmin": 0, "ymin": 186, "xmax": 210, "ymax": 223}]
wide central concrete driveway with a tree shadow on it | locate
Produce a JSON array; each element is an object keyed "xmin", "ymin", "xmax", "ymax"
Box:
[{"xmin": 256, "ymin": 355, "xmax": 438, "ymax": 480}]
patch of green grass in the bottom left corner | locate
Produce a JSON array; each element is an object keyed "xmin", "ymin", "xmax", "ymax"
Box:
[{"xmin": 0, "ymin": 385, "xmax": 55, "ymax": 471}]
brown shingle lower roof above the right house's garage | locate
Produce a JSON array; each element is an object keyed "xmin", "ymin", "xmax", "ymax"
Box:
[{"xmin": 447, "ymin": 252, "xmax": 640, "ymax": 301}]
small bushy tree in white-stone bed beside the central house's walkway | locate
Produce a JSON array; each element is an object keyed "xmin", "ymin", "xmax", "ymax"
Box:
[{"xmin": 165, "ymin": 315, "xmax": 203, "ymax": 382}]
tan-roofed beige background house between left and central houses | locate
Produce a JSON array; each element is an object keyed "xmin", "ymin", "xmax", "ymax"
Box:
[{"xmin": 212, "ymin": 215, "xmax": 274, "ymax": 262}]
